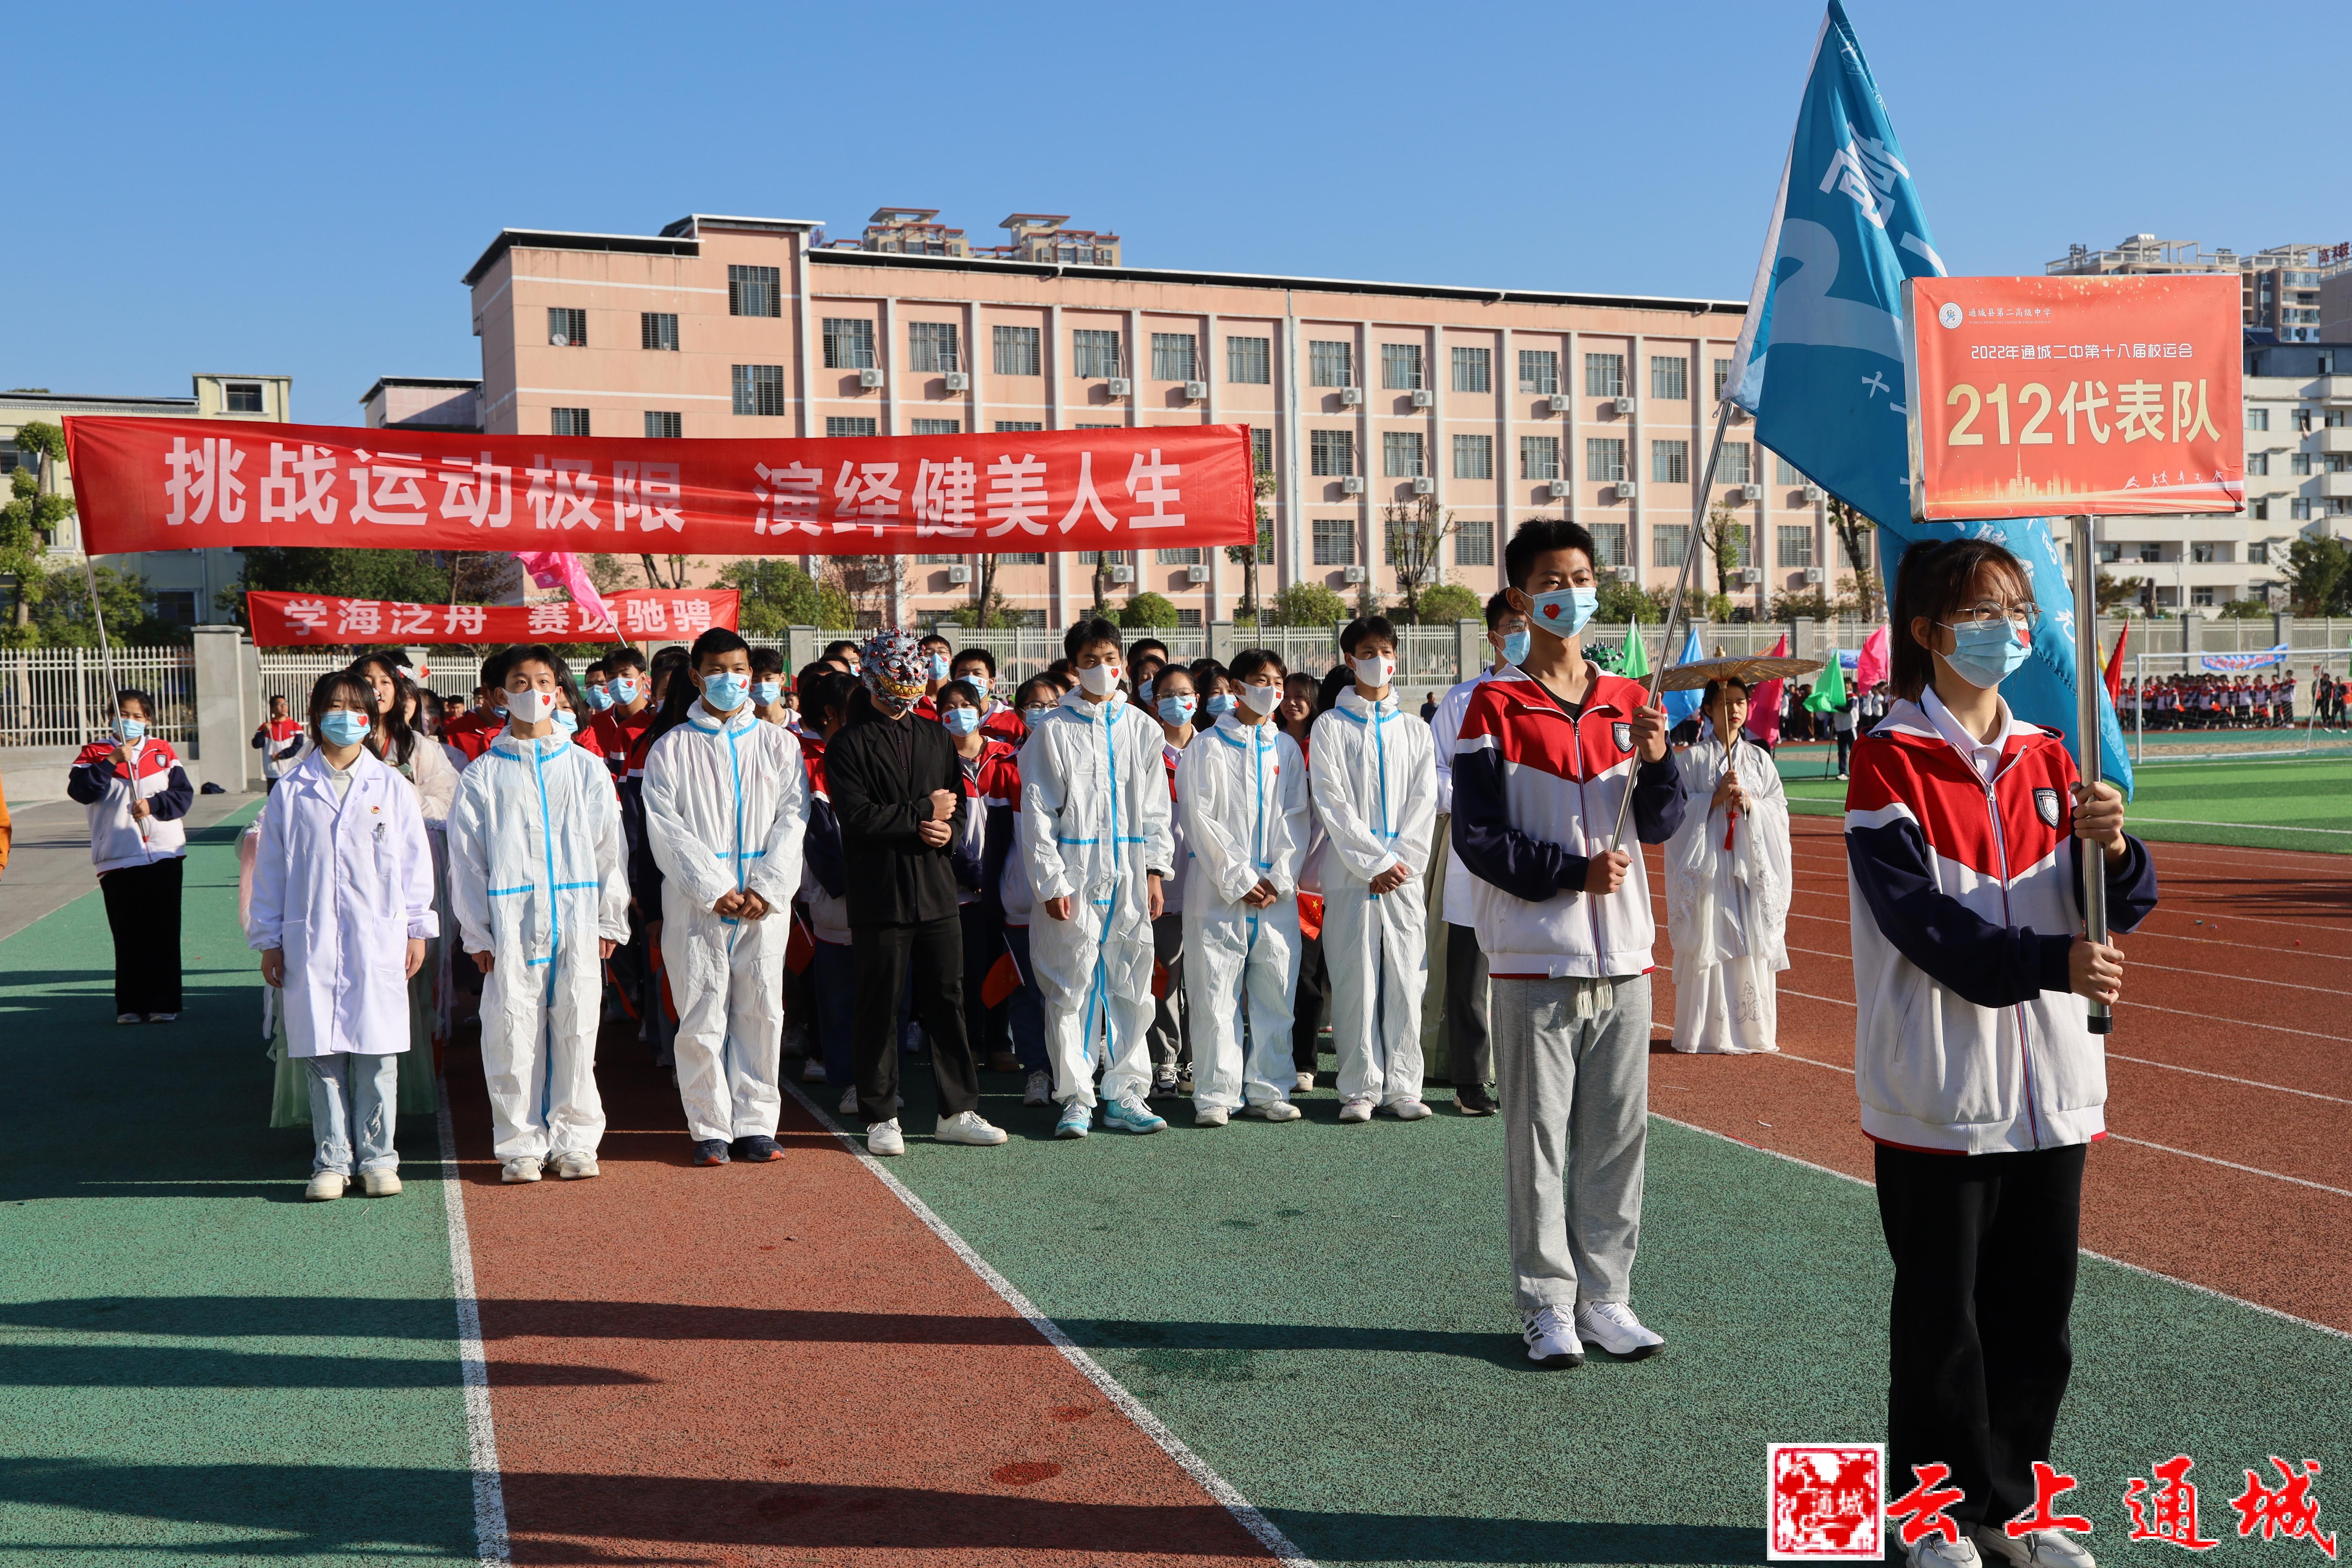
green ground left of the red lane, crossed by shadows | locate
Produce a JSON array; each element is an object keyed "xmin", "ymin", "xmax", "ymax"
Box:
[{"xmin": 0, "ymin": 813, "xmax": 473, "ymax": 1568}]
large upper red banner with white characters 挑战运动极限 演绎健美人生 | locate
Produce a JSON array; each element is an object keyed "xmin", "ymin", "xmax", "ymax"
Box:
[{"xmin": 66, "ymin": 414, "xmax": 1258, "ymax": 555}]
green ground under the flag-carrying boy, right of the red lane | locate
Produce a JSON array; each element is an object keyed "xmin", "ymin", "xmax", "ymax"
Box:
[{"xmin": 894, "ymin": 1091, "xmax": 2352, "ymax": 1563}]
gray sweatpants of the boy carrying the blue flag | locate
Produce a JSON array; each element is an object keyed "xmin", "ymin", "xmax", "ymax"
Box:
[{"xmin": 1491, "ymin": 975, "xmax": 1649, "ymax": 1312}]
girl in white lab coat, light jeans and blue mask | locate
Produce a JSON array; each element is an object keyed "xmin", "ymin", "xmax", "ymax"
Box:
[{"xmin": 245, "ymin": 672, "xmax": 440, "ymax": 1199}]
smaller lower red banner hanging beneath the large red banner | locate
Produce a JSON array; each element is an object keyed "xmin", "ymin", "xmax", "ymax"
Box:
[{"xmin": 245, "ymin": 588, "xmax": 743, "ymax": 649}]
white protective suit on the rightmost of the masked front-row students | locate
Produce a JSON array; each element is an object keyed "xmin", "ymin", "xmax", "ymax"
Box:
[{"xmin": 1308, "ymin": 686, "xmax": 1437, "ymax": 1105}]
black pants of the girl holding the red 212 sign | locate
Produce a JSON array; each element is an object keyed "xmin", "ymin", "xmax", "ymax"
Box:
[{"xmin": 1877, "ymin": 1142, "xmax": 2086, "ymax": 1526}]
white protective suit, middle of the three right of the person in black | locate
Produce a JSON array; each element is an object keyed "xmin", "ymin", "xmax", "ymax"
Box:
[{"xmin": 1176, "ymin": 712, "xmax": 1315, "ymax": 1112}]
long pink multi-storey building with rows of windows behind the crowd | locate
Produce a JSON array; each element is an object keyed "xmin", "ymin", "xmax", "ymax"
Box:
[{"xmin": 466, "ymin": 209, "xmax": 1832, "ymax": 628}]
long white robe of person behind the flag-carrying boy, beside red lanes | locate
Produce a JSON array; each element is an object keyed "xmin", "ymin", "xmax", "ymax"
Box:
[{"xmin": 1665, "ymin": 724, "xmax": 1792, "ymax": 1051}]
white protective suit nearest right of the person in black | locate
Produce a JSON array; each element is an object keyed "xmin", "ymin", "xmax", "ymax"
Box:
[{"xmin": 1021, "ymin": 691, "xmax": 1176, "ymax": 1110}]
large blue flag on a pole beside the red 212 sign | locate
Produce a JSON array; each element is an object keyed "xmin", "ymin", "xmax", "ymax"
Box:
[{"xmin": 1724, "ymin": 0, "xmax": 2131, "ymax": 792}]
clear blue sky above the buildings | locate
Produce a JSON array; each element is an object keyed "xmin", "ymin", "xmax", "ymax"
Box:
[{"xmin": 0, "ymin": 0, "xmax": 2352, "ymax": 423}]
